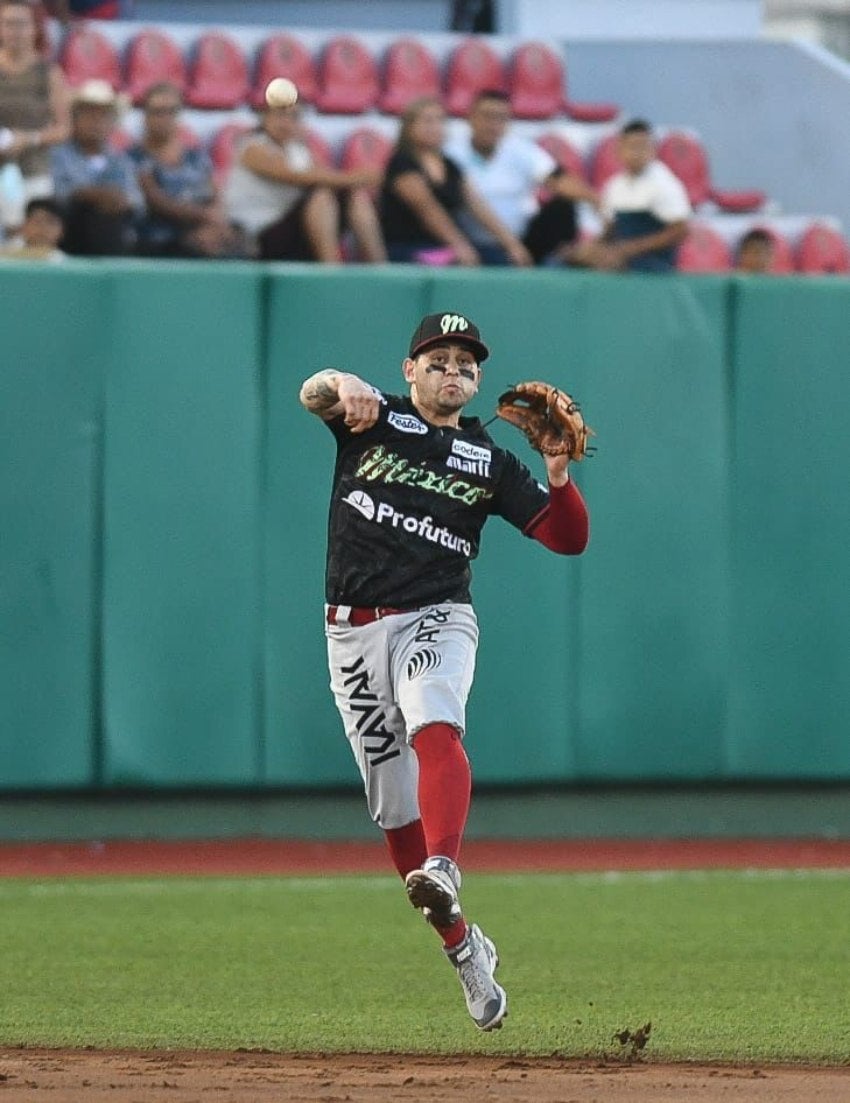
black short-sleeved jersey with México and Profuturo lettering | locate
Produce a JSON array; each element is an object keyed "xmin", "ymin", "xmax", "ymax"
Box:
[{"xmin": 325, "ymin": 395, "xmax": 549, "ymax": 609}]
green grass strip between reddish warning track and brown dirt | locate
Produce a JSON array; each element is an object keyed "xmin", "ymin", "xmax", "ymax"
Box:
[{"xmin": 0, "ymin": 871, "xmax": 850, "ymax": 1063}]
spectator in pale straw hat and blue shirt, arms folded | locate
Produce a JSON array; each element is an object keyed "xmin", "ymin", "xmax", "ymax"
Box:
[{"xmin": 52, "ymin": 79, "xmax": 144, "ymax": 256}]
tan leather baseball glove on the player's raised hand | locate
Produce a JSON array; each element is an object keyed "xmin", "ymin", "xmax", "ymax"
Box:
[{"xmin": 496, "ymin": 383, "xmax": 594, "ymax": 461}]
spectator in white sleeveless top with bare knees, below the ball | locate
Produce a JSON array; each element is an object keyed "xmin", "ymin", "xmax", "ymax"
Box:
[{"xmin": 224, "ymin": 105, "xmax": 386, "ymax": 264}]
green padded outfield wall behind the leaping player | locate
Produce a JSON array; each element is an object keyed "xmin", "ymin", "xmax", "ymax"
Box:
[{"xmin": 0, "ymin": 263, "xmax": 850, "ymax": 790}]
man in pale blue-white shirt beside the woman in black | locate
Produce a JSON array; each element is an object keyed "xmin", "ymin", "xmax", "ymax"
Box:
[{"xmin": 445, "ymin": 89, "xmax": 599, "ymax": 265}]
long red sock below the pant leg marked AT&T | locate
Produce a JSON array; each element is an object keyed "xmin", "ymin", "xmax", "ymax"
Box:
[{"xmin": 413, "ymin": 724, "xmax": 472, "ymax": 861}]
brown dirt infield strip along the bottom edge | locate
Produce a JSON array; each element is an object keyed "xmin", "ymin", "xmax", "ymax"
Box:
[{"xmin": 0, "ymin": 1050, "xmax": 850, "ymax": 1103}]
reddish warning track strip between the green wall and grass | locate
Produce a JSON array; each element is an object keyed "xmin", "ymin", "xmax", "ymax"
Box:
[{"xmin": 0, "ymin": 838, "xmax": 850, "ymax": 877}]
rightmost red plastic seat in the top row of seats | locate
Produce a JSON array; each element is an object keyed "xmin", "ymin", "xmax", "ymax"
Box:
[{"xmin": 508, "ymin": 42, "xmax": 620, "ymax": 122}]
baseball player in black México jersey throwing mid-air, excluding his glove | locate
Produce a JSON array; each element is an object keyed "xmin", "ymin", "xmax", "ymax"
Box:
[{"xmin": 300, "ymin": 312, "xmax": 588, "ymax": 1030}]
